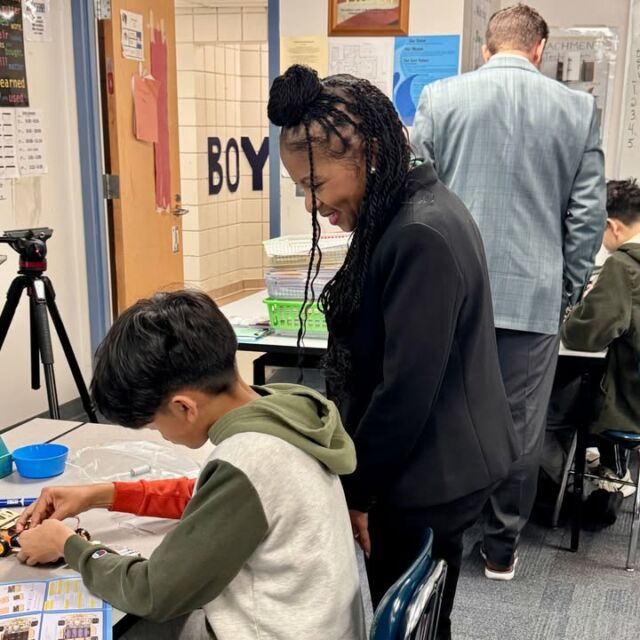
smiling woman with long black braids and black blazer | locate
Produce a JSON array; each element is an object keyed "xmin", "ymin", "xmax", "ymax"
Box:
[{"xmin": 268, "ymin": 65, "xmax": 516, "ymax": 638}]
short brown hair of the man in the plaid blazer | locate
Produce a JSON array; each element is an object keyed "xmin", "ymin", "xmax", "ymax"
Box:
[{"xmin": 486, "ymin": 4, "xmax": 549, "ymax": 55}]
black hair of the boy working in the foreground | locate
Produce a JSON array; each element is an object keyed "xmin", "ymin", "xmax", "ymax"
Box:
[{"xmin": 91, "ymin": 291, "xmax": 238, "ymax": 428}]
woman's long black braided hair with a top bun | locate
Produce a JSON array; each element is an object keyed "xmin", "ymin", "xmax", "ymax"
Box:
[{"xmin": 268, "ymin": 65, "xmax": 411, "ymax": 400}]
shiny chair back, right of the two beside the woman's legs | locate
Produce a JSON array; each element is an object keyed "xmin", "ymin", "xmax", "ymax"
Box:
[{"xmin": 400, "ymin": 560, "xmax": 447, "ymax": 640}]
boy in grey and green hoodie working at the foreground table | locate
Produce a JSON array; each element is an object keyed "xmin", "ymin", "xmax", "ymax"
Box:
[{"xmin": 13, "ymin": 291, "xmax": 365, "ymax": 640}]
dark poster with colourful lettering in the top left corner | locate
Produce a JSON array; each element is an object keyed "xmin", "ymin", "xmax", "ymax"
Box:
[{"xmin": 0, "ymin": 0, "xmax": 29, "ymax": 107}]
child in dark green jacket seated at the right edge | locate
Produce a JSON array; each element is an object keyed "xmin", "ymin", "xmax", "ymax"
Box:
[{"xmin": 562, "ymin": 180, "xmax": 640, "ymax": 477}]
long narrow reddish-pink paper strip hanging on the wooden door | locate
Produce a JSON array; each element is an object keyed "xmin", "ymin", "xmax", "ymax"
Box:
[{"xmin": 151, "ymin": 29, "xmax": 171, "ymax": 211}]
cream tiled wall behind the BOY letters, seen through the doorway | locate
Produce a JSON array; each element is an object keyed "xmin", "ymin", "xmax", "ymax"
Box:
[{"xmin": 176, "ymin": 3, "xmax": 269, "ymax": 291}]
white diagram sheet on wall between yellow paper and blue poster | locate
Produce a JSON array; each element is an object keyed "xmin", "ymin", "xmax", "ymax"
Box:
[{"xmin": 329, "ymin": 38, "xmax": 394, "ymax": 98}]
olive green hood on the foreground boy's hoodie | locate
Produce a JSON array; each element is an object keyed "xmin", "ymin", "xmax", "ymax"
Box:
[{"xmin": 209, "ymin": 384, "xmax": 356, "ymax": 475}]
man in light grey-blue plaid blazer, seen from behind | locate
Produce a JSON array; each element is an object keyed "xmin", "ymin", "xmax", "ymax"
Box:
[{"xmin": 412, "ymin": 4, "xmax": 606, "ymax": 580}]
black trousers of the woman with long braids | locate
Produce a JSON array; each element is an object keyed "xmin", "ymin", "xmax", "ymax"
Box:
[{"xmin": 367, "ymin": 479, "xmax": 492, "ymax": 640}]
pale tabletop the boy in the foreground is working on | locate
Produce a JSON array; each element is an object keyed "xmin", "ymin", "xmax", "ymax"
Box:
[{"xmin": 0, "ymin": 418, "xmax": 213, "ymax": 625}]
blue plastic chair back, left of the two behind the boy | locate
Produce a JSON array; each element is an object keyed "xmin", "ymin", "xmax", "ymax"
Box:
[{"xmin": 369, "ymin": 529, "xmax": 433, "ymax": 640}]
